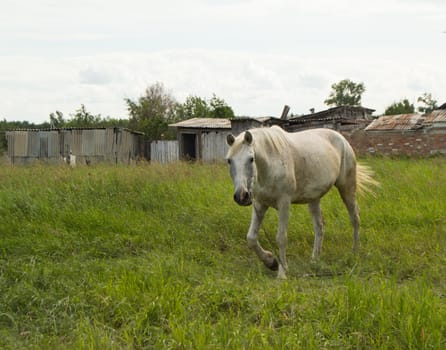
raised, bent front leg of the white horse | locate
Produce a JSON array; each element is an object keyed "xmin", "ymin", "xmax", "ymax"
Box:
[{"xmin": 246, "ymin": 202, "xmax": 279, "ymax": 271}]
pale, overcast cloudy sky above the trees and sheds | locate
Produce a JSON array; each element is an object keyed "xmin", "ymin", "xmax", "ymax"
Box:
[{"xmin": 0, "ymin": 0, "xmax": 446, "ymax": 123}]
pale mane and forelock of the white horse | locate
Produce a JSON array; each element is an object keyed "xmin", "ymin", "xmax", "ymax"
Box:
[{"xmin": 230, "ymin": 126, "xmax": 287, "ymax": 155}]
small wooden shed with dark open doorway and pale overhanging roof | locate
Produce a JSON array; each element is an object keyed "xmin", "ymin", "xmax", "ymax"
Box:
[{"xmin": 169, "ymin": 118, "xmax": 231, "ymax": 162}]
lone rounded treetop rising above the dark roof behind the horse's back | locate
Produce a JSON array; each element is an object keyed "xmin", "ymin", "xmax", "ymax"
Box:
[{"xmin": 324, "ymin": 79, "xmax": 365, "ymax": 106}]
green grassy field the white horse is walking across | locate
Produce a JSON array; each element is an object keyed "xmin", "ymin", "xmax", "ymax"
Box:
[{"xmin": 0, "ymin": 158, "xmax": 446, "ymax": 349}]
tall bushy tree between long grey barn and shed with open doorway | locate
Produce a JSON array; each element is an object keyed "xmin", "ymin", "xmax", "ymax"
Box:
[{"xmin": 125, "ymin": 82, "xmax": 178, "ymax": 141}]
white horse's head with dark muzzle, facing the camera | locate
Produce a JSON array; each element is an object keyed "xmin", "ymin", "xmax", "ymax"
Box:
[{"xmin": 226, "ymin": 131, "xmax": 256, "ymax": 205}]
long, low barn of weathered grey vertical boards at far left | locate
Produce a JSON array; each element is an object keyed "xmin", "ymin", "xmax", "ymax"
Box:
[{"xmin": 6, "ymin": 128, "xmax": 144, "ymax": 164}]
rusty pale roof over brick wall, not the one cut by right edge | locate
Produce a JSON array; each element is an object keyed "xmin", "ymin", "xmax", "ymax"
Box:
[{"xmin": 365, "ymin": 113, "xmax": 424, "ymax": 131}]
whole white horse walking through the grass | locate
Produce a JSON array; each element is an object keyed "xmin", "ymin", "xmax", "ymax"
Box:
[{"xmin": 226, "ymin": 126, "xmax": 378, "ymax": 278}]
